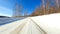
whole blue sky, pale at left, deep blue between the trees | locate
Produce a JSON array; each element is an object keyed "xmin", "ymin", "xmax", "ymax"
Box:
[{"xmin": 0, "ymin": 0, "xmax": 41, "ymax": 16}]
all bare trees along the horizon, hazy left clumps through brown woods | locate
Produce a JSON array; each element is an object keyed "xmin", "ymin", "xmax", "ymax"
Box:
[{"xmin": 13, "ymin": 0, "xmax": 60, "ymax": 17}]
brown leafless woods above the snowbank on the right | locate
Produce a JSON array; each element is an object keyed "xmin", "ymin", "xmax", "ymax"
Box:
[{"xmin": 31, "ymin": 0, "xmax": 60, "ymax": 16}]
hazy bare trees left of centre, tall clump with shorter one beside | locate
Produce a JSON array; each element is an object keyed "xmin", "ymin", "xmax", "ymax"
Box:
[{"xmin": 12, "ymin": 3, "xmax": 28, "ymax": 17}]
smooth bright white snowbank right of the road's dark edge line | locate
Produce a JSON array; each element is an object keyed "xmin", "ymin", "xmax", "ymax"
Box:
[{"xmin": 32, "ymin": 13, "xmax": 60, "ymax": 34}]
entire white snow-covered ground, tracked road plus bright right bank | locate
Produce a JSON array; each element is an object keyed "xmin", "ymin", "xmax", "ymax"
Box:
[{"xmin": 0, "ymin": 13, "xmax": 60, "ymax": 34}]
